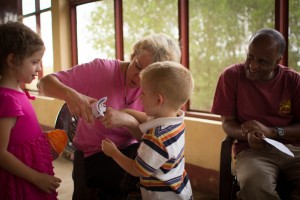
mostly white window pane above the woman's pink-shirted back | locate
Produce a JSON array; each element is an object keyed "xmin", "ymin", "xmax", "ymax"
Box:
[{"xmin": 76, "ymin": 0, "xmax": 116, "ymax": 64}]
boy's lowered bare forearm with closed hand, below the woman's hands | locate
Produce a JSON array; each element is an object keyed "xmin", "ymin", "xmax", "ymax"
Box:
[{"xmin": 102, "ymin": 138, "xmax": 140, "ymax": 176}]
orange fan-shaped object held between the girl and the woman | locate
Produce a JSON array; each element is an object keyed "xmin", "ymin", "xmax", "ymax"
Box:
[{"xmin": 45, "ymin": 129, "xmax": 68, "ymax": 160}]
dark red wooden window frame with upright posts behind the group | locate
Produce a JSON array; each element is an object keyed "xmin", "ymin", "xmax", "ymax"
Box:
[{"xmin": 70, "ymin": 0, "xmax": 289, "ymax": 121}]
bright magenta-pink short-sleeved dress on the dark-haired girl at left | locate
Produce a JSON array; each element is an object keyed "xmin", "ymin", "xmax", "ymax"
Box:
[{"xmin": 0, "ymin": 87, "xmax": 57, "ymax": 200}]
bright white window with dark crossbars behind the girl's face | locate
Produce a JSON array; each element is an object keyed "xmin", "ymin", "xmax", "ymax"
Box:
[{"xmin": 22, "ymin": 0, "xmax": 53, "ymax": 91}]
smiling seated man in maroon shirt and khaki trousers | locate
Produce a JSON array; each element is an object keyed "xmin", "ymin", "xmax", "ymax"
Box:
[{"xmin": 212, "ymin": 29, "xmax": 300, "ymax": 200}]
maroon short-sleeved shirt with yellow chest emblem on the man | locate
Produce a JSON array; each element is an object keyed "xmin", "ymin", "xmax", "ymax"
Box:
[{"xmin": 212, "ymin": 64, "xmax": 300, "ymax": 155}]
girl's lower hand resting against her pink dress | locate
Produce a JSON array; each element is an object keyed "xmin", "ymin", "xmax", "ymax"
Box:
[{"xmin": 34, "ymin": 173, "xmax": 61, "ymax": 194}]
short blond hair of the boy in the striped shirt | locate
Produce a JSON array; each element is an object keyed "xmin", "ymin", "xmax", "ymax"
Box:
[{"xmin": 140, "ymin": 61, "xmax": 194, "ymax": 109}]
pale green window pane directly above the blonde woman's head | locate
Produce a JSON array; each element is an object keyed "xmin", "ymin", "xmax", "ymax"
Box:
[{"xmin": 123, "ymin": 0, "xmax": 179, "ymax": 60}]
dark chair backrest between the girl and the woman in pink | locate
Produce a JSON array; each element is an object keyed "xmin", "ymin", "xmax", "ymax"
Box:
[{"xmin": 55, "ymin": 103, "xmax": 78, "ymax": 153}]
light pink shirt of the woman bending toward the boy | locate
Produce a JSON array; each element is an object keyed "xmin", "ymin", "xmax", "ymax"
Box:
[{"xmin": 54, "ymin": 59, "xmax": 143, "ymax": 156}]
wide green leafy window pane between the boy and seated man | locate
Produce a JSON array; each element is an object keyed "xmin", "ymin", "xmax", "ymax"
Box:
[{"xmin": 189, "ymin": 0, "xmax": 275, "ymax": 112}]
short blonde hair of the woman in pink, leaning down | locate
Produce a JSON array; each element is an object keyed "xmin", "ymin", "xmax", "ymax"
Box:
[{"xmin": 130, "ymin": 33, "xmax": 181, "ymax": 62}]
